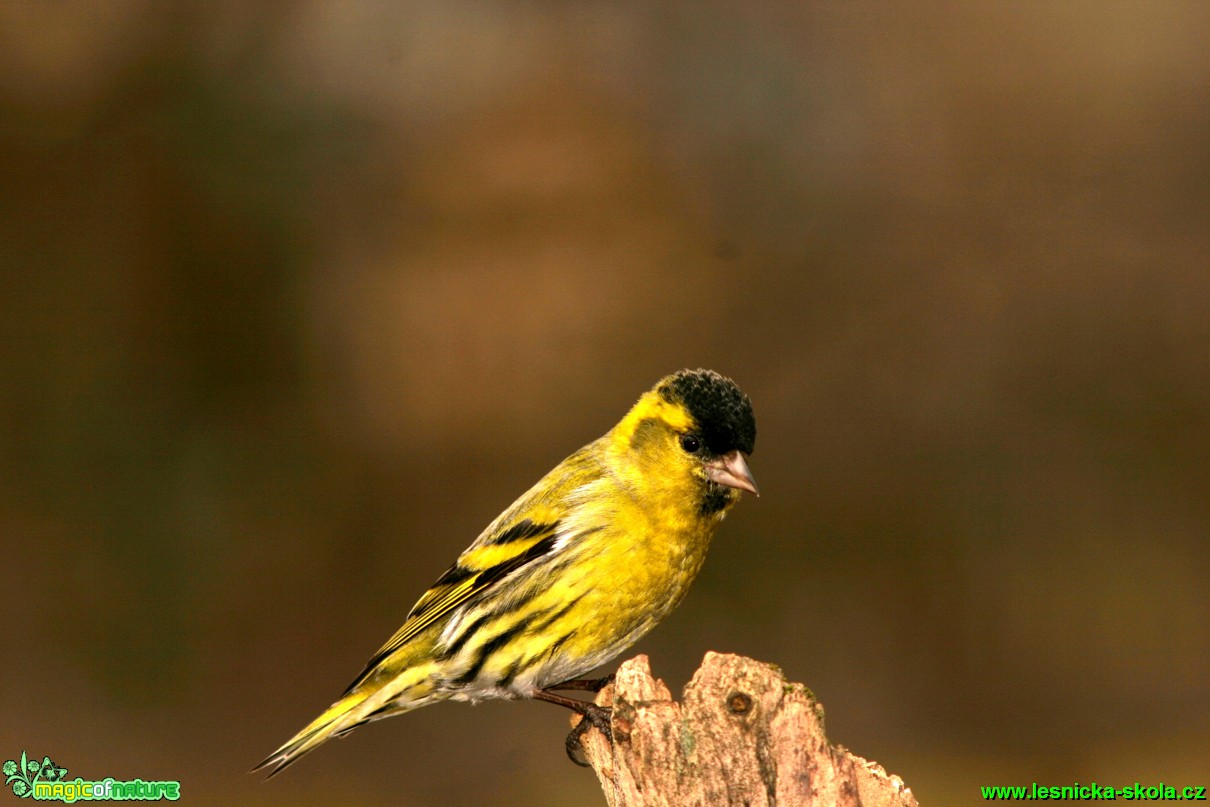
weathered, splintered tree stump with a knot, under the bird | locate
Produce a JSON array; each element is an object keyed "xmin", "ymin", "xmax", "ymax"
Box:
[{"xmin": 572, "ymin": 652, "xmax": 918, "ymax": 807}]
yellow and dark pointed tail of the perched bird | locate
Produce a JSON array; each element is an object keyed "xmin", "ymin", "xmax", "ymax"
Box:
[{"xmin": 253, "ymin": 664, "xmax": 436, "ymax": 778}]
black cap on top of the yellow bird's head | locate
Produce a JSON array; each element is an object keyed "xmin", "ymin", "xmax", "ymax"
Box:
[{"xmin": 657, "ymin": 370, "xmax": 756, "ymax": 455}]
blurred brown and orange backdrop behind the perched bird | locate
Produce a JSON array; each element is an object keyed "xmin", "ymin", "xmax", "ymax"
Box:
[{"xmin": 0, "ymin": 0, "xmax": 1210, "ymax": 805}]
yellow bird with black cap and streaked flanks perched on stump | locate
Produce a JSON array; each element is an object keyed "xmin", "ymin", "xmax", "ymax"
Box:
[{"xmin": 253, "ymin": 369, "xmax": 760, "ymax": 777}]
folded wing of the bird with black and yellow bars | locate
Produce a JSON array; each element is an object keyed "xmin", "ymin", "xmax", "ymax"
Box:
[{"xmin": 345, "ymin": 518, "xmax": 559, "ymax": 694}]
